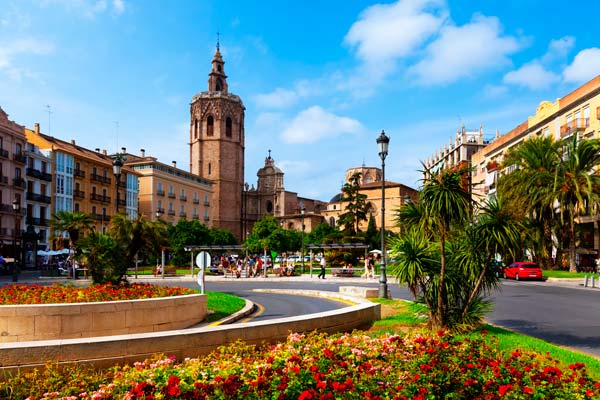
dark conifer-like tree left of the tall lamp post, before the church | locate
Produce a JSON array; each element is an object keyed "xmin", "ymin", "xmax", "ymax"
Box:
[{"xmin": 338, "ymin": 172, "xmax": 371, "ymax": 235}]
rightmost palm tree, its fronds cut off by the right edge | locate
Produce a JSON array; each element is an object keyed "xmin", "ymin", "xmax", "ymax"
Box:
[{"xmin": 553, "ymin": 135, "xmax": 600, "ymax": 272}]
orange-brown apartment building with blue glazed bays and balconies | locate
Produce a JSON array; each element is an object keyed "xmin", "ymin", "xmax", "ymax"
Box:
[{"xmin": 25, "ymin": 124, "xmax": 140, "ymax": 238}]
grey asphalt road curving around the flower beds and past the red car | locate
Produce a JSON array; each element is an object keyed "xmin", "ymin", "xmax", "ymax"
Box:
[{"xmin": 0, "ymin": 275, "xmax": 600, "ymax": 357}]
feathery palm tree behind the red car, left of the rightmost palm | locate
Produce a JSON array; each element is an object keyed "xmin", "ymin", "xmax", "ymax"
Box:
[{"xmin": 497, "ymin": 136, "xmax": 561, "ymax": 265}]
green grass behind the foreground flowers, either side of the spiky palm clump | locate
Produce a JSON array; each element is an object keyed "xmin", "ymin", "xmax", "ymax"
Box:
[{"xmin": 369, "ymin": 299, "xmax": 600, "ymax": 380}]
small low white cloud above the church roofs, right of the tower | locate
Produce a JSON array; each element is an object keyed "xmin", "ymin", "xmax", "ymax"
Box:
[{"xmin": 282, "ymin": 106, "xmax": 363, "ymax": 143}]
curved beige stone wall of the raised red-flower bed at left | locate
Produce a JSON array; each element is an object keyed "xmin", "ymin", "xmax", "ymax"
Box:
[{"xmin": 0, "ymin": 294, "xmax": 207, "ymax": 343}]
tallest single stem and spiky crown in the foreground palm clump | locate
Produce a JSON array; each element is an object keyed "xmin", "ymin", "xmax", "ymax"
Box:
[{"xmin": 420, "ymin": 168, "xmax": 471, "ymax": 327}]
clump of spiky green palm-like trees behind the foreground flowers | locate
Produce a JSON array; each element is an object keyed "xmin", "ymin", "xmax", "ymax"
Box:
[{"xmin": 389, "ymin": 184, "xmax": 520, "ymax": 330}]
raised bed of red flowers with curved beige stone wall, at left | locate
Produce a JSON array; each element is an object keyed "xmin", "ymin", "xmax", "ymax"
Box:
[{"xmin": 0, "ymin": 285, "xmax": 208, "ymax": 343}]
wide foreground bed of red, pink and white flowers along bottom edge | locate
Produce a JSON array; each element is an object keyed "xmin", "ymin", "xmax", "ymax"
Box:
[{"xmin": 0, "ymin": 332, "xmax": 600, "ymax": 400}]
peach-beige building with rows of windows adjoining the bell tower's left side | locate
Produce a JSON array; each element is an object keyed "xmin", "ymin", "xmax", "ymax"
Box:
[{"xmin": 125, "ymin": 149, "xmax": 213, "ymax": 228}]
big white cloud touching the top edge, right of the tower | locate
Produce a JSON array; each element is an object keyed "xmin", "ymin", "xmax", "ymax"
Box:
[{"xmin": 344, "ymin": 0, "xmax": 447, "ymax": 64}]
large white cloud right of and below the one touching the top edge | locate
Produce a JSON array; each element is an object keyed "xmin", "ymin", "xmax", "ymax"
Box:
[{"xmin": 409, "ymin": 14, "xmax": 521, "ymax": 85}]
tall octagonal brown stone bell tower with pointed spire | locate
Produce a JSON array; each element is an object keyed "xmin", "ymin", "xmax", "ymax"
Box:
[{"xmin": 189, "ymin": 42, "xmax": 245, "ymax": 240}]
